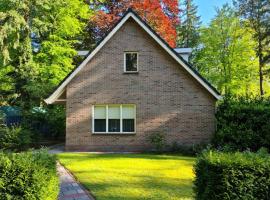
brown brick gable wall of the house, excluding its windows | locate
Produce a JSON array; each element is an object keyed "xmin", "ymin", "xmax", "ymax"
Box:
[{"xmin": 66, "ymin": 19, "xmax": 215, "ymax": 151}]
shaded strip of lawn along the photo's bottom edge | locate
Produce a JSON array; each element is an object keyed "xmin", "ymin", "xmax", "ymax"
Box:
[{"xmin": 82, "ymin": 176, "xmax": 193, "ymax": 200}]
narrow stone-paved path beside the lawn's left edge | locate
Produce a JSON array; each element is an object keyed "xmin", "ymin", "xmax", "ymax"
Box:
[{"xmin": 57, "ymin": 163, "xmax": 94, "ymax": 200}]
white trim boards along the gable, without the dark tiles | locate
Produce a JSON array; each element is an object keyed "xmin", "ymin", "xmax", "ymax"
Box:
[{"xmin": 45, "ymin": 12, "xmax": 222, "ymax": 104}]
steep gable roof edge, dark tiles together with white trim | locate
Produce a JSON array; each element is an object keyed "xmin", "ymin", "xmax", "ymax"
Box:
[{"xmin": 45, "ymin": 9, "xmax": 222, "ymax": 104}]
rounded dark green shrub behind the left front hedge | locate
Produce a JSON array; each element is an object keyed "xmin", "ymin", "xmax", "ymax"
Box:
[{"xmin": 0, "ymin": 125, "xmax": 32, "ymax": 151}]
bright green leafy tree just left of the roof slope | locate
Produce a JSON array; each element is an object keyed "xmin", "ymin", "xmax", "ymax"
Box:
[{"xmin": 26, "ymin": 0, "xmax": 91, "ymax": 100}]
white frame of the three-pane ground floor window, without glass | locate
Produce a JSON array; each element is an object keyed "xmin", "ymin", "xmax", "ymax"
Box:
[{"xmin": 92, "ymin": 104, "xmax": 136, "ymax": 134}]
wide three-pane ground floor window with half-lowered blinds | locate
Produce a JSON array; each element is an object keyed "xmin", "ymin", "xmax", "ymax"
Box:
[{"xmin": 92, "ymin": 104, "xmax": 136, "ymax": 133}]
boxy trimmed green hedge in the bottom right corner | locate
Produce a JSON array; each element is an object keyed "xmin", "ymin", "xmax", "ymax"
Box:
[{"xmin": 194, "ymin": 151, "xmax": 270, "ymax": 200}]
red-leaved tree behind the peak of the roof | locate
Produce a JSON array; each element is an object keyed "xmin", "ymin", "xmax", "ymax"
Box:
[{"xmin": 89, "ymin": 0, "xmax": 179, "ymax": 47}]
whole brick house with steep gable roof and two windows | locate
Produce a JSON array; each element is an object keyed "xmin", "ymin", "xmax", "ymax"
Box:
[{"xmin": 45, "ymin": 10, "xmax": 221, "ymax": 151}]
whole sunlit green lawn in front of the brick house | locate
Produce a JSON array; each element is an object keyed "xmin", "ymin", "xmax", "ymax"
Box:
[{"xmin": 58, "ymin": 153, "xmax": 195, "ymax": 200}]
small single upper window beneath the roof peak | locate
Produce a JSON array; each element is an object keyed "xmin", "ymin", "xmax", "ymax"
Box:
[{"xmin": 124, "ymin": 52, "xmax": 138, "ymax": 73}]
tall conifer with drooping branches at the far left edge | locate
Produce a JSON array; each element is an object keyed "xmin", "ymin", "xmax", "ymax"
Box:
[{"xmin": 0, "ymin": 0, "xmax": 35, "ymax": 102}]
